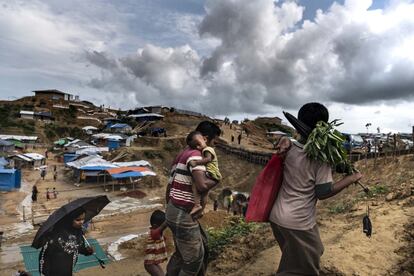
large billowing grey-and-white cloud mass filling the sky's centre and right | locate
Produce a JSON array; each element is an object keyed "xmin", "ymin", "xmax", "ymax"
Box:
[{"xmin": 81, "ymin": 0, "xmax": 414, "ymax": 114}]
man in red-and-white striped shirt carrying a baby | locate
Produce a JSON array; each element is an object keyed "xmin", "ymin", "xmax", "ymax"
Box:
[{"xmin": 166, "ymin": 121, "xmax": 221, "ymax": 276}]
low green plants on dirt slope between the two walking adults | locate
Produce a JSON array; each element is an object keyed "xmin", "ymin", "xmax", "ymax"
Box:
[{"xmin": 207, "ymin": 218, "xmax": 259, "ymax": 260}]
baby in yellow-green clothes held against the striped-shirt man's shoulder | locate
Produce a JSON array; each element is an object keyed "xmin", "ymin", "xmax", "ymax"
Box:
[{"xmin": 186, "ymin": 131, "xmax": 222, "ymax": 215}]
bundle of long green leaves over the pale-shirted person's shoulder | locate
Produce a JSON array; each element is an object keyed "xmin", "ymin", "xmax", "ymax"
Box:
[{"xmin": 304, "ymin": 120, "xmax": 355, "ymax": 174}]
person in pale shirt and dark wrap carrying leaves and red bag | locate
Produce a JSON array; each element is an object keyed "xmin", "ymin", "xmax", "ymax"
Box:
[{"xmin": 269, "ymin": 103, "xmax": 362, "ymax": 275}]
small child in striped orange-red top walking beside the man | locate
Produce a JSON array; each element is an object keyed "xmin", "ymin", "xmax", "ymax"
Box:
[{"xmin": 144, "ymin": 210, "xmax": 168, "ymax": 276}]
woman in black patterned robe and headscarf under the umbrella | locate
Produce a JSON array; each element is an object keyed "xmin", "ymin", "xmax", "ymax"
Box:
[{"xmin": 39, "ymin": 209, "xmax": 93, "ymax": 276}]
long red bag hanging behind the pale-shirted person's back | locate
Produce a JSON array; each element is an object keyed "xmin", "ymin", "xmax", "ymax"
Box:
[{"xmin": 246, "ymin": 154, "xmax": 284, "ymax": 222}]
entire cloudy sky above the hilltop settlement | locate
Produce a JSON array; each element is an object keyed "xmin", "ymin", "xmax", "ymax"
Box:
[{"xmin": 0, "ymin": 0, "xmax": 414, "ymax": 132}]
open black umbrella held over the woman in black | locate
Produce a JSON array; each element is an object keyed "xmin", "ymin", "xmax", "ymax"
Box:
[{"xmin": 32, "ymin": 195, "xmax": 109, "ymax": 248}]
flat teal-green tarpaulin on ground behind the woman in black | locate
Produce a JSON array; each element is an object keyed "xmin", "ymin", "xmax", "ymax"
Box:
[{"xmin": 20, "ymin": 239, "xmax": 109, "ymax": 276}]
